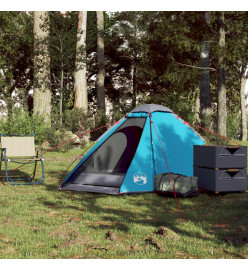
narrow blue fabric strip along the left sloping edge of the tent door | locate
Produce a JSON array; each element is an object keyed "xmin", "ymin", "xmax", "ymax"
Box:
[{"xmin": 62, "ymin": 118, "xmax": 127, "ymax": 185}]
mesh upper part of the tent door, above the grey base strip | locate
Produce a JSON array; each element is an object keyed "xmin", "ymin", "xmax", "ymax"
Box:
[{"xmin": 74, "ymin": 118, "xmax": 146, "ymax": 177}]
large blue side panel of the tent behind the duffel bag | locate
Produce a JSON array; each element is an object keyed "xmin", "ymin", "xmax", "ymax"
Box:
[{"xmin": 152, "ymin": 112, "xmax": 204, "ymax": 176}]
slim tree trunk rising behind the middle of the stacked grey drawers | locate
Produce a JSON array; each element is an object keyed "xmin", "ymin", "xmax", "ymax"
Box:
[{"xmin": 217, "ymin": 11, "xmax": 226, "ymax": 136}]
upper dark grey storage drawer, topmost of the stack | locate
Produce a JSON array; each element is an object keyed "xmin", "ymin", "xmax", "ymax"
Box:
[{"xmin": 194, "ymin": 145, "xmax": 247, "ymax": 169}]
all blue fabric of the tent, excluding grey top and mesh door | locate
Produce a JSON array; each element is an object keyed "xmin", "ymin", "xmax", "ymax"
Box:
[{"xmin": 63, "ymin": 108, "xmax": 204, "ymax": 193}]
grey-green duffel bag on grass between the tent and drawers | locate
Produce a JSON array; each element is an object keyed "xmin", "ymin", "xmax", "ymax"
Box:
[{"xmin": 154, "ymin": 173, "xmax": 199, "ymax": 197}]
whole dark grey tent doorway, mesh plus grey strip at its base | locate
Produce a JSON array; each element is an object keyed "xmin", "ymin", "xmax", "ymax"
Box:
[{"xmin": 63, "ymin": 118, "xmax": 146, "ymax": 194}]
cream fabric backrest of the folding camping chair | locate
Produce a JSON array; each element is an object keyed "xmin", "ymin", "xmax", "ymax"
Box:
[{"xmin": 1, "ymin": 136, "xmax": 35, "ymax": 157}]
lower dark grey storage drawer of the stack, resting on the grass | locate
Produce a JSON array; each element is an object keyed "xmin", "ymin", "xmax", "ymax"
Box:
[{"xmin": 194, "ymin": 167, "xmax": 247, "ymax": 192}]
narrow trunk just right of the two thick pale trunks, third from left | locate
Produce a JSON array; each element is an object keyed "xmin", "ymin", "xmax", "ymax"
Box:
[{"xmin": 96, "ymin": 11, "xmax": 106, "ymax": 115}]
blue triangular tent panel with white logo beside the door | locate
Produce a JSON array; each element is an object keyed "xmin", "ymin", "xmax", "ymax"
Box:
[{"xmin": 120, "ymin": 117, "xmax": 154, "ymax": 193}]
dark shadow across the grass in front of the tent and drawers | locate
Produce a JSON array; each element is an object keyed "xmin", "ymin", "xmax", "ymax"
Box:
[{"xmin": 40, "ymin": 171, "xmax": 248, "ymax": 246}]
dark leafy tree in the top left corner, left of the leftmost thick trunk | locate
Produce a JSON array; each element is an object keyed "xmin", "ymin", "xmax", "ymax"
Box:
[{"xmin": 0, "ymin": 11, "xmax": 33, "ymax": 113}]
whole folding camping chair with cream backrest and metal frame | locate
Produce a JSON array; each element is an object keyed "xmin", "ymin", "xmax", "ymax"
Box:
[{"xmin": 0, "ymin": 134, "xmax": 45, "ymax": 185}]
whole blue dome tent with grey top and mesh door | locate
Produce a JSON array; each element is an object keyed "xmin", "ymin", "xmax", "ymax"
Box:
[{"xmin": 60, "ymin": 104, "xmax": 204, "ymax": 194}]
